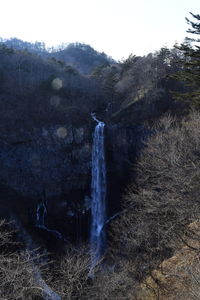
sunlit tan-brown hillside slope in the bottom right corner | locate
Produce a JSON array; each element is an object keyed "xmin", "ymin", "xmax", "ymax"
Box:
[{"xmin": 137, "ymin": 220, "xmax": 200, "ymax": 300}]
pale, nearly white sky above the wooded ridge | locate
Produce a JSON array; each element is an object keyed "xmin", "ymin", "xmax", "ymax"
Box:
[{"xmin": 0, "ymin": 0, "xmax": 200, "ymax": 60}]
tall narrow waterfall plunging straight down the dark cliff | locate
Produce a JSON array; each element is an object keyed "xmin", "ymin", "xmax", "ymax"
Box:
[{"xmin": 90, "ymin": 114, "xmax": 106, "ymax": 266}]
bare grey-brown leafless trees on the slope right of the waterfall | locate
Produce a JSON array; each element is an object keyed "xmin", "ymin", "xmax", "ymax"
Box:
[{"xmin": 111, "ymin": 112, "xmax": 200, "ymax": 286}]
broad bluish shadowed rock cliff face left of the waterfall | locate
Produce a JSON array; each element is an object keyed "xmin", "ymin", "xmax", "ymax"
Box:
[{"xmin": 0, "ymin": 119, "xmax": 92, "ymax": 241}]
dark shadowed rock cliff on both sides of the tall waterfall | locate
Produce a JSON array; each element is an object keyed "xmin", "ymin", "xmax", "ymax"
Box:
[{"xmin": 0, "ymin": 110, "xmax": 145, "ymax": 246}]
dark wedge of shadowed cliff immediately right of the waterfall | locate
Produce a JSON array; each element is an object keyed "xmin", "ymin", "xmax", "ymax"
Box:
[{"xmin": 106, "ymin": 122, "xmax": 149, "ymax": 217}]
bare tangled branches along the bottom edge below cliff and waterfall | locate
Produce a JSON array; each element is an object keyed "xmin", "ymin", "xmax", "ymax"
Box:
[{"xmin": 0, "ymin": 220, "xmax": 139, "ymax": 300}]
